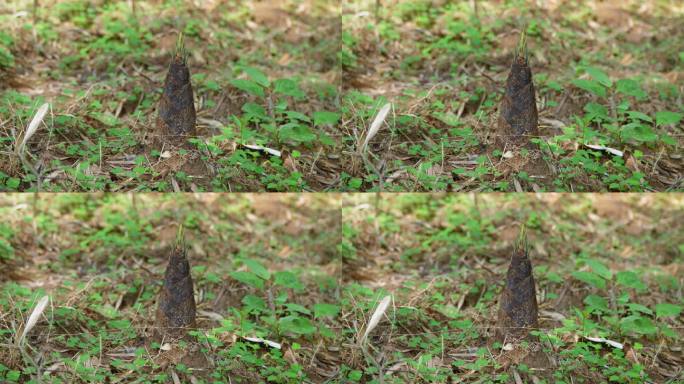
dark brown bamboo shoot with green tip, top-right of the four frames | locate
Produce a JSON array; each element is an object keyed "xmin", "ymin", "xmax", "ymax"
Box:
[{"xmin": 496, "ymin": 31, "xmax": 539, "ymax": 148}]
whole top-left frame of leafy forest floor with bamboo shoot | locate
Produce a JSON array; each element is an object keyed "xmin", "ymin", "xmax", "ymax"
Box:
[{"xmin": 0, "ymin": 0, "xmax": 341, "ymax": 191}]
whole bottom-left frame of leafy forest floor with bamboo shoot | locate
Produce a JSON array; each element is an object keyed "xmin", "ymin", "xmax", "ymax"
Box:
[{"xmin": 0, "ymin": 194, "xmax": 341, "ymax": 383}]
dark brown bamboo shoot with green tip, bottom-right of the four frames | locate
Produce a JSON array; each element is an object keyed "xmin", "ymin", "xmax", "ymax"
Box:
[{"xmin": 498, "ymin": 226, "xmax": 538, "ymax": 341}]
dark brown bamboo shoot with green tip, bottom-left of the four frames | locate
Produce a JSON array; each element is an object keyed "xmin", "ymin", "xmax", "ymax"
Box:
[{"xmin": 155, "ymin": 228, "xmax": 196, "ymax": 340}]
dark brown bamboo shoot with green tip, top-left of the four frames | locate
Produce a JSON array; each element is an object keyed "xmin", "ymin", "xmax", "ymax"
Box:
[{"xmin": 155, "ymin": 34, "xmax": 196, "ymax": 145}]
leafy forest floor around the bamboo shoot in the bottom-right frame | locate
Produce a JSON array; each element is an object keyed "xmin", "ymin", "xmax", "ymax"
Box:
[{"xmin": 340, "ymin": 194, "xmax": 684, "ymax": 383}]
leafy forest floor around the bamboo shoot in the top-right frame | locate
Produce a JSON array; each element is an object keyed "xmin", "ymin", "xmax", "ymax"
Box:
[{"xmin": 340, "ymin": 0, "xmax": 684, "ymax": 191}]
